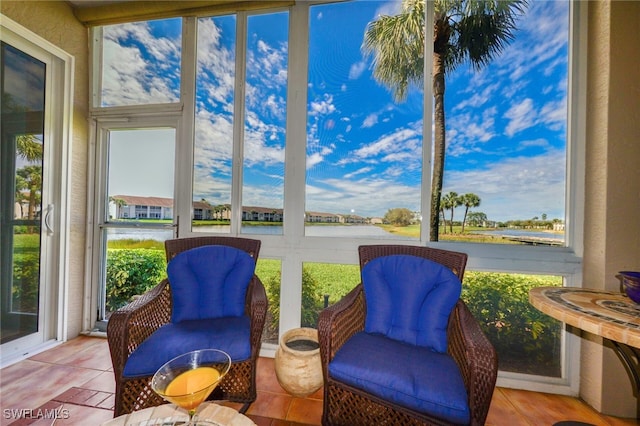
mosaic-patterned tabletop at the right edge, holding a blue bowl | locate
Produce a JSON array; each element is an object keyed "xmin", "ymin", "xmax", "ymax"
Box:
[{"xmin": 529, "ymin": 287, "xmax": 640, "ymax": 348}]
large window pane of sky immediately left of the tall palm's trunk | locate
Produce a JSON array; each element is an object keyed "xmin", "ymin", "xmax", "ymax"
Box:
[{"xmin": 305, "ymin": 1, "xmax": 424, "ymax": 239}]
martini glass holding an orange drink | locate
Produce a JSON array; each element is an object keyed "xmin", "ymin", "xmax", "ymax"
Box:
[{"xmin": 151, "ymin": 349, "xmax": 231, "ymax": 425}]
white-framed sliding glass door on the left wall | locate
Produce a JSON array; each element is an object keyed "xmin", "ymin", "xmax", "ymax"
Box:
[{"xmin": 0, "ymin": 18, "xmax": 71, "ymax": 366}]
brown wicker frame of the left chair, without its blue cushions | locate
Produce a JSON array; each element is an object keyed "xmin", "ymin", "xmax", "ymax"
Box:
[{"xmin": 107, "ymin": 237, "xmax": 267, "ymax": 417}]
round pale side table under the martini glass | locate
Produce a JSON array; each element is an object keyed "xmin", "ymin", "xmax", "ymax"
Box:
[{"xmin": 102, "ymin": 402, "xmax": 256, "ymax": 426}]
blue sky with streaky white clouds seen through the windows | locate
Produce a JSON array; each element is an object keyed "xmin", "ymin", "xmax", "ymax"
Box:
[{"xmin": 103, "ymin": 1, "xmax": 568, "ymax": 225}]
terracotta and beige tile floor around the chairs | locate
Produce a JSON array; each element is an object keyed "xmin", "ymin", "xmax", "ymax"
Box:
[{"xmin": 0, "ymin": 336, "xmax": 640, "ymax": 426}]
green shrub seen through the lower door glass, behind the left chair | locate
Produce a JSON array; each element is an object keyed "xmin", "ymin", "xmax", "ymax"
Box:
[{"xmin": 106, "ymin": 249, "xmax": 167, "ymax": 312}]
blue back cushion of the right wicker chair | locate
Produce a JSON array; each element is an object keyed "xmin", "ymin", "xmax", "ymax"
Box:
[{"xmin": 362, "ymin": 255, "xmax": 462, "ymax": 352}]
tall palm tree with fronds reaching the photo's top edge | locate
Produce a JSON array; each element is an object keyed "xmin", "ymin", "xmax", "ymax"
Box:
[{"xmin": 362, "ymin": 0, "xmax": 527, "ymax": 241}]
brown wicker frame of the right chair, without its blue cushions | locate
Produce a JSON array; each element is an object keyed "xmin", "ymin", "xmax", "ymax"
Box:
[{"xmin": 318, "ymin": 245, "xmax": 498, "ymax": 426}]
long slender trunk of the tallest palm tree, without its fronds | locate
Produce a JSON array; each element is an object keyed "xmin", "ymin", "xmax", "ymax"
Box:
[{"xmin": 429, "ymin": 52, "xmax": 446, "ymax": 241}]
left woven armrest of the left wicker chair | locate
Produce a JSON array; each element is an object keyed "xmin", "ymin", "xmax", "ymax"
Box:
[{"xmin": 107, "ymin": 279, "xmax": 171, "ymax": 377}]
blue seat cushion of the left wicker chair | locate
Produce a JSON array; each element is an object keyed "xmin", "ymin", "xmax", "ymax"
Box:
[{"xmin": 123, "ymin": 316, "xmax": 251, "ymax": 378}]
